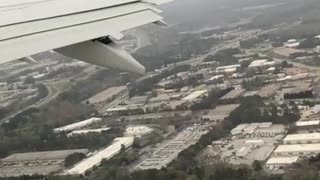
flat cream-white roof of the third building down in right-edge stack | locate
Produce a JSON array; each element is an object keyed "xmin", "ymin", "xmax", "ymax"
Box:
[{"xmin": 274, "ymin": 144, "xmax": 320, "ymax": 153}]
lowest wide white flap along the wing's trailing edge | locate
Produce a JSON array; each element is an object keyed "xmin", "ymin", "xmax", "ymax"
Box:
[{"xmin": 0, "ymin": 10, "xmax": 162, "ymax": 63}]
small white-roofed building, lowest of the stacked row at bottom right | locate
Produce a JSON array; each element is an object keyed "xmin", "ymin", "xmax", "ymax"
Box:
[{"xmin": 266, "ymin": 156, "xmax": 299, "ymax": 170}]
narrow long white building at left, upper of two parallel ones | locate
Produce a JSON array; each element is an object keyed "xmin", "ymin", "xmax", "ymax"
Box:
[{"xmin": 53, "ymin": 117, "xmax": 102, "ymax": 133}]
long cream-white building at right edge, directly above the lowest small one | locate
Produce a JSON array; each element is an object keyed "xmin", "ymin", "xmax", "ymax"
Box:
[{"xmin": 274, "ymin": 143, "xmax": 320, "ymax": 156}]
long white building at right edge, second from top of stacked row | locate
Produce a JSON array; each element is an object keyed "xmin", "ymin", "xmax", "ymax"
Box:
[{"xmin": 283, "ymin": 133, "xmax": 320, "ymax": 144}]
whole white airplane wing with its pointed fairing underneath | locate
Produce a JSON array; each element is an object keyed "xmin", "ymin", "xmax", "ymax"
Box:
[{"xmin": 0, "ymin": 0, "xmax": 170, "ymax": 74}]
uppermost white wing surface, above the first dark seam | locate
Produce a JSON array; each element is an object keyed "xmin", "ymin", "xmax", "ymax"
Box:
[{"xmin": 0, "ymin": 0, "xmax": 139, "ymax": 26}]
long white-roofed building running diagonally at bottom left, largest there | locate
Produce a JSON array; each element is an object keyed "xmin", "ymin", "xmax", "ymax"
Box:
[{"xmin": 65, "ymin": 137, "xmax": 134, "ymax": 175}]
